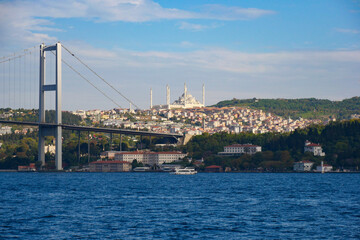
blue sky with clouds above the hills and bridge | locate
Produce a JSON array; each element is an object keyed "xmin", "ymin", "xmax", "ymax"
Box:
[{"xmin": 0, "ymin": 0, "xmax": 360, "ymax": 110}]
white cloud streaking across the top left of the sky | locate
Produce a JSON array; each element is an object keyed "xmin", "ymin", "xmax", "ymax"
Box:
[{"xmin": 0, "ymin": 0, "xmax": 273, "ymax": 46}]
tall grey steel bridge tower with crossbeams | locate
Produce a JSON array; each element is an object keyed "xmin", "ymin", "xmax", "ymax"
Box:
[{"xmin": 38, "ymin": 42, "xmax": 63, "ymax": 170}]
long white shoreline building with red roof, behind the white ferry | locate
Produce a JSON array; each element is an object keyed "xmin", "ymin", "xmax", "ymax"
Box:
[{"xmin": 115, "ymin": 151, "xmax": 187, "ymax": 166}]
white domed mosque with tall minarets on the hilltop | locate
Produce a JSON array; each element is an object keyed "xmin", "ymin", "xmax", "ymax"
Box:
[{"xmin": 150, "ymin": 83, "xmax": 205, "ymax": 109}]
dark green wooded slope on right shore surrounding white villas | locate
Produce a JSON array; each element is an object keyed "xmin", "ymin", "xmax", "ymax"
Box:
[{"xmin": 184, "ymin": 120, "xmax": 360, "ymax": 171}]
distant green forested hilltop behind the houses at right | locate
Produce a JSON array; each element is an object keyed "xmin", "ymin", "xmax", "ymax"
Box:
[{"xmin": 214, "ymin": 97, "xmax": 360, "ymax": 119}]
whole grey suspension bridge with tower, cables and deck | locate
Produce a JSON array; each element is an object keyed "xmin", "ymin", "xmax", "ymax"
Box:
[{"xmin": 0, "ymin": 42, "xmax": 183, "ymax": 170}]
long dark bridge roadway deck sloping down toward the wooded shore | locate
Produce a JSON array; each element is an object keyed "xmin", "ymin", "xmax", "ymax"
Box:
[{"xmin": 0, "ymin": 120, "xmax": 183, "ymax": 138}]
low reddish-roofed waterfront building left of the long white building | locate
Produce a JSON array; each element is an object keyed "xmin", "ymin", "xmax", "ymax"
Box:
[{"xmin": 89, "ymin": 161, "xmax": 131, "ymax": 172}]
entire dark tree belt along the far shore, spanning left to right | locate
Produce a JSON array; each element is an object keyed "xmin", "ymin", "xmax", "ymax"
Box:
[{"xmin": 0, "ymin": 120, "xmax": 360, "ymax": 171}]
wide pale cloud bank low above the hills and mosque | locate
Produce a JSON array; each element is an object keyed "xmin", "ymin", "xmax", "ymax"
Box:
[{"xmin": 55, "ymin": 43, "xmax": 360, "ymax": 107}]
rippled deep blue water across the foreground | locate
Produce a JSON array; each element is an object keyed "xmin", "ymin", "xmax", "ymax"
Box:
[{"xmin": 0, "ymin": 173, "xmax": 360, "ymax": 239}]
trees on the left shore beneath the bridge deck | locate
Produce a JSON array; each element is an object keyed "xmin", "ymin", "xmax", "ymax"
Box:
[{"xmin": 0, "ymin": 131, "xmax": 134, "ymax": 169}]
